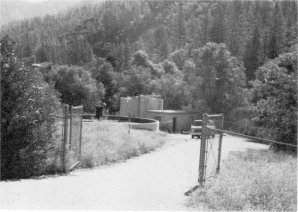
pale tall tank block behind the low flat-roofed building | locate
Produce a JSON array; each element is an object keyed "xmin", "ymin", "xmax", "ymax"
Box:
[{"xmin": 119, "ymin": 95, "xmax": 163, "ymax": 118}]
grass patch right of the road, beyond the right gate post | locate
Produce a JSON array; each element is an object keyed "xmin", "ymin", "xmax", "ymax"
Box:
[{"xmin": 188, "ymin": 150, "xmax": 297, "ymax": 211}]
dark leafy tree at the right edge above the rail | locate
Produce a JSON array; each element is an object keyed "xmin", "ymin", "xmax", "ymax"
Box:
[{"xmin": 252, "ymin": 51, "xmax": 297, "ymax": 149}]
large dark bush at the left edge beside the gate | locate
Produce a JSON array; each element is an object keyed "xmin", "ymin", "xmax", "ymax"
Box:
[{"xmin": 1, "ymin": 36, "xmax": 58, "ymax": 179}]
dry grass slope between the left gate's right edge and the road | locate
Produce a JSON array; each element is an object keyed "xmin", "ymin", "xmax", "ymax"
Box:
[{"xmin": 81, "ymin": 121, "xmax": 167, "ymax": 167}]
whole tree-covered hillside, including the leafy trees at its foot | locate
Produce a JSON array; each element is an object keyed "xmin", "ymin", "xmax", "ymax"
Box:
[{"xmin": 1, "ymin": 0, "xmax": 297, "ymax": 153}]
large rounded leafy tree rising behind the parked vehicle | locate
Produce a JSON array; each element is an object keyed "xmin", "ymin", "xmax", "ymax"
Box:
[{"xmin": 189, "ymin": 43, "xmax": 245, "ymax": 115}]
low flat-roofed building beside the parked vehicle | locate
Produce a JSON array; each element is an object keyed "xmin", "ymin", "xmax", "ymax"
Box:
[{"xmin": 147, "ymin": 110, "xmax": 202, "ymax": 132}]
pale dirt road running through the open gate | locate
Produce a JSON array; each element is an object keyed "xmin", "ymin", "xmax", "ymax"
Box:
[{"xmin": 0, "ymin": 135, "xmax": 268, "ymax": 210}]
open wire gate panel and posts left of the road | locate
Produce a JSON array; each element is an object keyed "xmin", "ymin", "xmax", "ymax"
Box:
[{"xmin": 55, "ymin": 105, "xmax": 83, "ymax": 173}]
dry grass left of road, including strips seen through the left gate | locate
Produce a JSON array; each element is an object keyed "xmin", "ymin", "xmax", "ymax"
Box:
[{"xmin": 46, "ymin": 120, "xmax": 171, "ymax": 174}]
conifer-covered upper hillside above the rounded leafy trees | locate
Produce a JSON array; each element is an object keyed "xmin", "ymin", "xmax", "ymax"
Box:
[{"xmin": 2, "ymin": 1, "xmax": 297, "ymax": 74}]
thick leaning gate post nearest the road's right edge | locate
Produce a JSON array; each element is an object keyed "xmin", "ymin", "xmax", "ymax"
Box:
[{"xmin": 198, "ymin": 113, "xmax": 208, "ymax": 186}]
